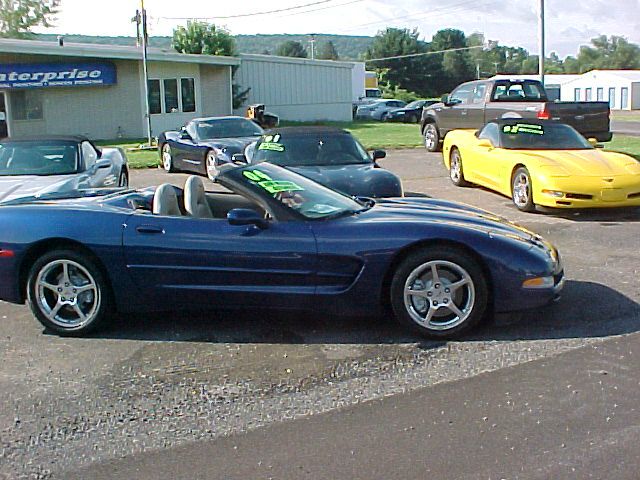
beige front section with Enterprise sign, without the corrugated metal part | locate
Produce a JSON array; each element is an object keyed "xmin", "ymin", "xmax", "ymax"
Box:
[{"xmin": 0, "ymin": 39, "xmax": 240, "ymax": 139}]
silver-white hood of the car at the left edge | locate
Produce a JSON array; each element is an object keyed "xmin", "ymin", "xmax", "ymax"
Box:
[{"xmin": 0, "ymin": 175, "xmax": 79, "ymax": 202}]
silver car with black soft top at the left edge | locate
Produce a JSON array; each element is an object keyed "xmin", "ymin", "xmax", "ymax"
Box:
[{"xmin": 0, "ymin": 136, "xmax": 129, "ymax": 201}]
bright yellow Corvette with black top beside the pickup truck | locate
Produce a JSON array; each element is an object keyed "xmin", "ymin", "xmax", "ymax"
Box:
[{"xmin": 442, "ymin": 118, "xmax": 640, "ymax": 212}]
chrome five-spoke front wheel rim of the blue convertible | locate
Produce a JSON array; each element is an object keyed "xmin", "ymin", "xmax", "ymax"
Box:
[{"xmin": 404, "ymin": 260, "xmax": 476, "ymax": 331}]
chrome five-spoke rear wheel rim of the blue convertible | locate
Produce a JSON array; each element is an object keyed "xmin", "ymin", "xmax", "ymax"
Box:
[{"xmin": 35, "ymin": 259, "xmax": 101, "ymax": 329}]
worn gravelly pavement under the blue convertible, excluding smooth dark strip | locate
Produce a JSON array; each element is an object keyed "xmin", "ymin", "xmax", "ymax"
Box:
[{"xmin": 0, "ymin": 149, "xmax": 640, "ymax": 478}]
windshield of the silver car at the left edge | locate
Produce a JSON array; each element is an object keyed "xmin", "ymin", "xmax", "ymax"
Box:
[{"xmin": 0, "ymin": 141, "xmax": 79, "ymax": 176}]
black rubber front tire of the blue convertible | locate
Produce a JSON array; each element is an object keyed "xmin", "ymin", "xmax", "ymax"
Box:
[{"xmin": 390, "ymin": 246, "xmax": 489, "ymax": 338}]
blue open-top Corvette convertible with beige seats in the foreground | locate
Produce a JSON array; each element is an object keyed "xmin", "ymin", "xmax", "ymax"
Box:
[{"xmin": 0, "ymin": 162, "xmax": 563, "ymax": 337}]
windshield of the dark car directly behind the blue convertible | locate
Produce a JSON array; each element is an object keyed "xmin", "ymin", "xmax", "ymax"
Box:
[{"xmin": 250, "ymin": 131, "xmax": 372, "ymax": 167}]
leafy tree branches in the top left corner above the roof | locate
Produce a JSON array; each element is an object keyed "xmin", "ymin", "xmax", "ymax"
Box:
[{"xmin": 0, "ymin": 0, "xmax": 60, "ymax": 38}]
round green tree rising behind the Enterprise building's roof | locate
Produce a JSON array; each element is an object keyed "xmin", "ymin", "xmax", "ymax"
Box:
[{"xmin": 172, "ymin": 21, "xmax": 236, "ymax": 56}]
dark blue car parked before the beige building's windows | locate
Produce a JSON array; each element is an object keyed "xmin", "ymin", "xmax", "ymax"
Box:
[{"xmin": 158, "ymin": 116, "xmax": 264, "ymax": 181}]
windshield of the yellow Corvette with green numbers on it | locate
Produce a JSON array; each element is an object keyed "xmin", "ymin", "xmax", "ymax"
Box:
[{"xmin": 500, "ymin": 121, "xmax": 593, "ymax": 150}]
